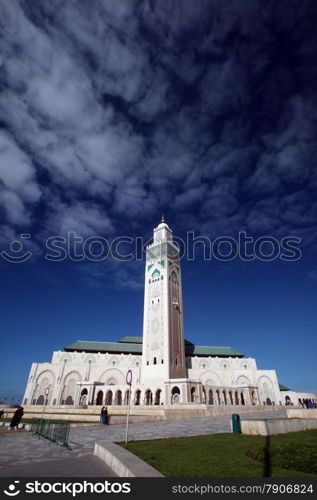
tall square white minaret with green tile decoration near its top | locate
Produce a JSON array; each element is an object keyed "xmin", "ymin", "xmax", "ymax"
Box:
[{"xmin": 142, "ymin": 216, "xmax": 186, "ymax": 384}]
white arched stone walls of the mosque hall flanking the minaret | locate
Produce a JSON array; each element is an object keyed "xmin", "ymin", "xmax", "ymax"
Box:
[{"xmin": 23, "ymin": 351, "xmax": 285, "ymax": 405}]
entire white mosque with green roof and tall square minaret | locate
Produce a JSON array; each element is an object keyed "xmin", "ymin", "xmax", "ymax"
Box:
[{"xmin": 23, "ymin": 218, "xmax": 312, "ymax": 406}]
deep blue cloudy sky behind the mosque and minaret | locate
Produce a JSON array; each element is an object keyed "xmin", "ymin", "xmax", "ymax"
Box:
[{"xmin": 0, "ymin": 0, "xmax": 317, "ymax": 397}]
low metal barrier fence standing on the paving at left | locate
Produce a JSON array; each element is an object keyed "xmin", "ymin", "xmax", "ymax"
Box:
[{"xmin": 31, "ymin": 418, "xmax": 69, "ymax": 448}]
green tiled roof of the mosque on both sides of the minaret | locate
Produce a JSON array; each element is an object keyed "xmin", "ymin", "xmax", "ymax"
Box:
[{"xmin": 65, "ymin": 337, "xmax": 244, "ymax": 358}]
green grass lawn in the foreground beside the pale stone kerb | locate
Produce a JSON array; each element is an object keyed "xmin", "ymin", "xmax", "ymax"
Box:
[{"xmin": 119, "ymin": 430, "xmax": 317, "ymax": 477}]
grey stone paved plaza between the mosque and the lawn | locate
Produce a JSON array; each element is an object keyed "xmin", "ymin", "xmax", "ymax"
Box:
[{"xmin": 0, "ymin": 409, "xmax": 286, "ymax": 477}]
